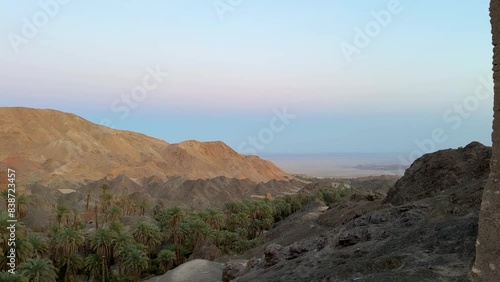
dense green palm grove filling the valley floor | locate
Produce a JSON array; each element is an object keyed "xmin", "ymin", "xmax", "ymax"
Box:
[{"xmin": 0, "ymin": 185, "xmax": 351, "ymax": 282}]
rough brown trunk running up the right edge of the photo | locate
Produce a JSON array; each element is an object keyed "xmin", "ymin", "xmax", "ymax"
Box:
[{"xmin": 472, "ymin": 0, "xmax": 500, "ymax": 282}]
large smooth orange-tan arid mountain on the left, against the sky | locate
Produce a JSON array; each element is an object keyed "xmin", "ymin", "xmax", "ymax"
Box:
[{"xmin": 0, "ymin": 108, "xmax": 289, "ymax": 188}]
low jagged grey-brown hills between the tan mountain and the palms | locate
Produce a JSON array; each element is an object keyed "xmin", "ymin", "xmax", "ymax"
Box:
[{"xmin": 25, "ymin": 174, "xmax": 304, "ymax": 228}]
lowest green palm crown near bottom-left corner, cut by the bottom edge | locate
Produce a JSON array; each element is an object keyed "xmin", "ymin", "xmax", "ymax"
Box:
[{"xmin": 19, "ymin": 257, "xmax": 57, "ymax": 282}]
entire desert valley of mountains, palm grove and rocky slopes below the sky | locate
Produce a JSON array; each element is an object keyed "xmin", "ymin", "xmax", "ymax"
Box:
[{"xmin": 0, "ymin": 108, "xmax": 491, "ymax": 282}]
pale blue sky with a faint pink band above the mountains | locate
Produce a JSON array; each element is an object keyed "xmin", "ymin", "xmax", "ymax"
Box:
[{"xmin": 0, "ymin": 0, "xmax": 493, "ymax": 156}]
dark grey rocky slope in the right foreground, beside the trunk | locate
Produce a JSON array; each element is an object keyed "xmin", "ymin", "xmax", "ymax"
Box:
[{"xmin": 223, "ymin": 142, "xmax": 491, "ymax": 282}]
